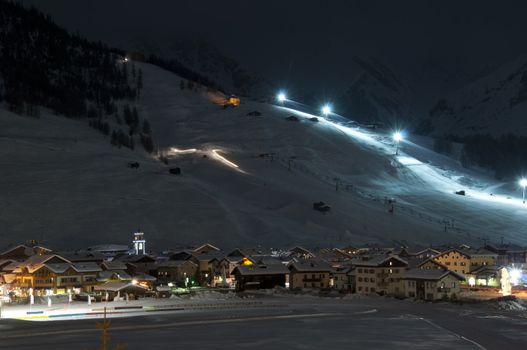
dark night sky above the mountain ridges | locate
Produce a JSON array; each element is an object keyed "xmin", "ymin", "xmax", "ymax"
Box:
[{"xmin": 24, "ymin": 0, "xmax": 527, "ymax": 92}]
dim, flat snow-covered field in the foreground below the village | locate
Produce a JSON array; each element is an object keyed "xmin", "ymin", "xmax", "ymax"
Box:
[{"xmin": 0, "ymin": 293, "xmax": 527, "ymax": 349}]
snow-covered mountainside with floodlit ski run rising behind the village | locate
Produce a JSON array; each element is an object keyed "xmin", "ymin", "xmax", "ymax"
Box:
[{"xmin": 0, "ymin": 64, "xmax": 527, "ymax": 249}]
